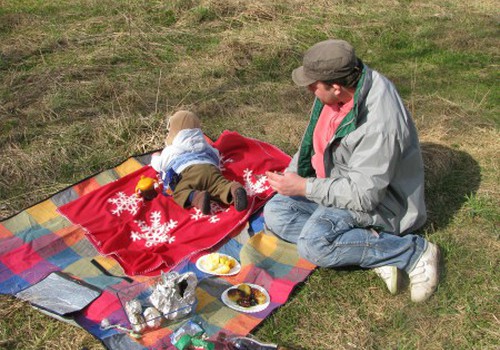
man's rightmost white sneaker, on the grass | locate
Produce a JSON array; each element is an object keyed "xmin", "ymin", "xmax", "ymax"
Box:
[{"xmin": 408, "ymin": 242, "xmax": 440, "ymax": 303}]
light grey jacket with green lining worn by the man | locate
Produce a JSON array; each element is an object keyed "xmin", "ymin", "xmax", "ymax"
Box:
[{"xmin": 287, "ymin": 66, "xmax": 427, "ymax": 235}]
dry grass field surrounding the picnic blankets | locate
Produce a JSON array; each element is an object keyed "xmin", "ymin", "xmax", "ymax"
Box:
[{"xmin": 0, "ymin": 0, "xmax": 500, "ymax": 350}]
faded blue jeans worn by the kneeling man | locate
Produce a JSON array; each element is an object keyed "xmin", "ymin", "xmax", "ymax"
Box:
[{"xmin": 264, "ymin": 194, "xmax": 427, "ymax": 272}]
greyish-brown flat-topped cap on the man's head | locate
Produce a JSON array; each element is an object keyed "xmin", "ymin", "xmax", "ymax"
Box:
[{"xmin": 292, "ymin": 39, "xmax": 358, "ymax": 86}]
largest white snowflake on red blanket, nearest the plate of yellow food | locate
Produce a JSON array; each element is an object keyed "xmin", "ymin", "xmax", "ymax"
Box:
[{"xmin": 130, "ymin": 211, "xmax": 178, "ymax": 248}]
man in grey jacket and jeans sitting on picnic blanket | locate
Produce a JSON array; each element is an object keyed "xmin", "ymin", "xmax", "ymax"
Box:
[{"xmin": 264, "ymin": 40, "xmax": 439, "ymax": 302}]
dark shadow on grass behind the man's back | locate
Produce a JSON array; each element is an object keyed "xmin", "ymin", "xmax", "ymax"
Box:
[{"xmin": 421, "ymin": 142, "xmax": 481, "ymax": 233}]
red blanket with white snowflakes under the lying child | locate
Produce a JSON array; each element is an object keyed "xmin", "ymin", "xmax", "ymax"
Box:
[{"xmin": 59, "ymin": 131, "xmax": 290, "ymax": 275}]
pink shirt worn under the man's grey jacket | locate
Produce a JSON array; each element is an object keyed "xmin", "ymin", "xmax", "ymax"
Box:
[{"xmin": 311, "ymin": 99, "xmax": 354, "ymax": 178}]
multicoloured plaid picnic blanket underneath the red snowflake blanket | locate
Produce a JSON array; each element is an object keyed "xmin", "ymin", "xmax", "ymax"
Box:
[{"xmin": 0, "ymin": 133, "xmax": 314, "ymax": 350}]
